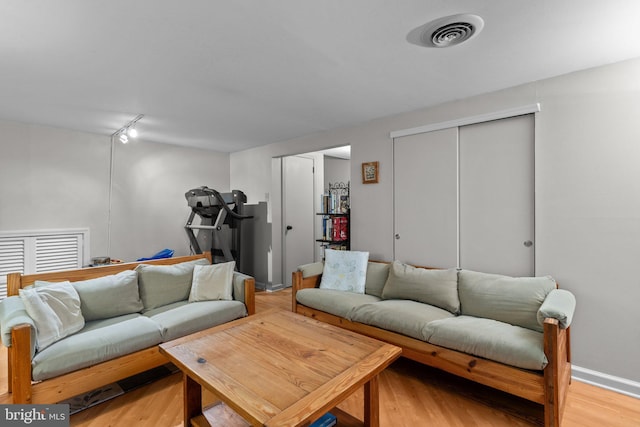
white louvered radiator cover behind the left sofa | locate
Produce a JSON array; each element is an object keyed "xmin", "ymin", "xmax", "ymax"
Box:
[{"xmin": 0, "ymin": 228, "xmax": 89, "ymax": 299}]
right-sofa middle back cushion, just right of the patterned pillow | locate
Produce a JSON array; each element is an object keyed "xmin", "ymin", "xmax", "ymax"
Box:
[{"xmin": 382, "ymin": 261, "xmax": 460, "ymax": 314}]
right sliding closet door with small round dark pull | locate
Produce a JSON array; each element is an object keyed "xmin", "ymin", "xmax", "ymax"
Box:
[{"xmin": 459, "ymin": 114, "xmax": 535, "ymax": 276}]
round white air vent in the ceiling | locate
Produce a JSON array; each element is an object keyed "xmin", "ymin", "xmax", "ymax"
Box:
[{"xmin": 407, "ymin": 14, "xmax": 484, "ymax": 47}]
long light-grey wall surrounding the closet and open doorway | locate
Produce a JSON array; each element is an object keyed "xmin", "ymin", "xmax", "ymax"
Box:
[{"xmin": 231, "ymin": 59, "xmax": 640, "ymax": 390}]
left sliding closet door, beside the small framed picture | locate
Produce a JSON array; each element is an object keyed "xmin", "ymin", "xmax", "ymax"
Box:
[{"xmin": 392, "ymin": 128, "xmax": 458, "ymax": 268}]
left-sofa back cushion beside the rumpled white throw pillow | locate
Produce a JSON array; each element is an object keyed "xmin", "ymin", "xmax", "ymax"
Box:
[{"xmin": 44, "ymin": 270, "xmax": 143, "ymax": 322}]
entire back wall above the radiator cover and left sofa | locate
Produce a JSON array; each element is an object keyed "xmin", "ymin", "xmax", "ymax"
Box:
[{"xmin": 0, "ymin": 121, "xmax": 229, "ymax": 262}]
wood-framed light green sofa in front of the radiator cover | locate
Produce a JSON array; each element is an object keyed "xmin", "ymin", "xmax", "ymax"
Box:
[{"xmin": 0, "ymin": 255, "xmax": 255, "ymax": 403}]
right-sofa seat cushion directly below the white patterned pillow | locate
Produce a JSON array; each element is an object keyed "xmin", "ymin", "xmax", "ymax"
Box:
[{"xmin": 296, "ymin": 288, "xmax": 380, "ymax": 318}]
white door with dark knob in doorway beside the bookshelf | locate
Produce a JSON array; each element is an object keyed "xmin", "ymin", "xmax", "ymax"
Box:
[{"xmin": 282, "ymin": 156, "xmax": 315, "ymax": 286}]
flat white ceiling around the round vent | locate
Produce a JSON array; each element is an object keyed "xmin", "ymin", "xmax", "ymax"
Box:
[{"xmin": 0, "ymin": 0, "xmax": 640, "ymax": 152}]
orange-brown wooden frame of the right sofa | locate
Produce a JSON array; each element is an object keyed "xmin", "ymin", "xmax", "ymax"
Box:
[{"xmin": 292, "ymin": 271, "xmax": 571, "ymax": 427}]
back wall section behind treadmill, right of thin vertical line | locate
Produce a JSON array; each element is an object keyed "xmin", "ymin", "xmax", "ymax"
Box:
[{"xmin": 111, "ymin": 141, "xmax": 230, "ymax": 260}]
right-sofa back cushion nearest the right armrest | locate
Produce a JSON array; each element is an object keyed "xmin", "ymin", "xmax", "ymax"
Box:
[{"xmin": 458, "ymin": 270, "xmax": 556, "ymax": 332}]
